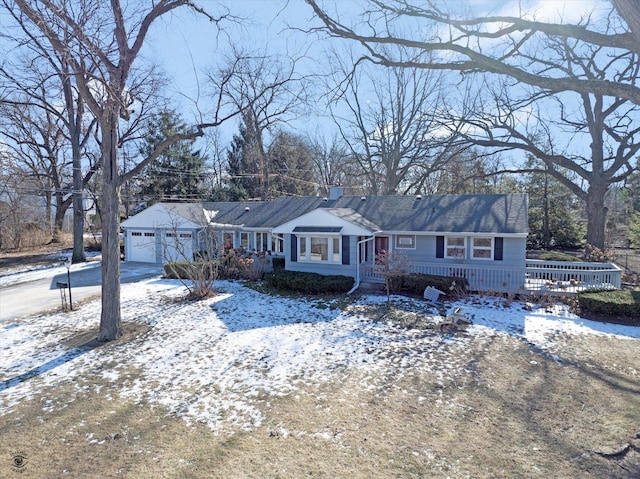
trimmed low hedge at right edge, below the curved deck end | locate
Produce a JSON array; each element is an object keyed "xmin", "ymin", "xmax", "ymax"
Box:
[{"xmin": 578, "ymin": 290, "xmax": 640, "ymax": 325}]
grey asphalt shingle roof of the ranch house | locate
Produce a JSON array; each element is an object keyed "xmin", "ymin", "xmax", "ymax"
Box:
[{"xmin": 148, "ymin": 194, "xmax": 528, "ymax": 234}]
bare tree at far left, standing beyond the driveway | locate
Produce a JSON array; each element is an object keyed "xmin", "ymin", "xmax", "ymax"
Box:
[{"xmin": 0, "ymin": 0, "xmax": 96, "ymax": 263}]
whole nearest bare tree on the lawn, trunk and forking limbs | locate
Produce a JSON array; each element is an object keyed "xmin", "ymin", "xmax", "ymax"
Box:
[{"xmin": 9, "ymin": 0, "xmax": 235, "ymax": 341}]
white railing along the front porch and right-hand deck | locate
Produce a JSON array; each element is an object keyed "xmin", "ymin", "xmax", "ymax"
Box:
[{"xmin": 360, "ymin": 259, "xmax": 622, "ymax": 294}]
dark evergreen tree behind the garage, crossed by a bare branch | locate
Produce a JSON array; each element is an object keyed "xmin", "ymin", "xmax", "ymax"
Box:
[{"xmin": 139, "ymin": 111, "xmax": 205, "ymax": 204}]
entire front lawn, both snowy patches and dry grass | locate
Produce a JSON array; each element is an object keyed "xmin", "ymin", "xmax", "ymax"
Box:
[{"xmin": 0, "ymin": 281, "xmax": 640, "ymax": 478}]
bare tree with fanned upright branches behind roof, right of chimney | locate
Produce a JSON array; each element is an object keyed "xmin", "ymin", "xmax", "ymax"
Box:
[{"xmin": 330, "ymin": 48, "xmax": 462, "ymax": 195}]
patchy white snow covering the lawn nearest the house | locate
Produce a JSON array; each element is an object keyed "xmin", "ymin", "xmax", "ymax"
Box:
[{"xmin": 0, "ymin": 278, "xmax": 640, "ymax": 431}]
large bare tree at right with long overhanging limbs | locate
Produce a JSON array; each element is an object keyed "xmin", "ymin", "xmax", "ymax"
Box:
[{"xmin": 307, "ymin": 0, "xmax": 640, "ymax": 248}]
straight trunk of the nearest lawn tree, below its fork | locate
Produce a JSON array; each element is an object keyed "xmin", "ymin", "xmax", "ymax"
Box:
[{"xmin": 98, "ymin": 116, "xmax": 122, "ymax": 341}]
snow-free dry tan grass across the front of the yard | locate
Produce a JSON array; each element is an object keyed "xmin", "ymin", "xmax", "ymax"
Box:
[{"xmin": 0, "ymin": 328, "xmax": 640, "ymax": 479}]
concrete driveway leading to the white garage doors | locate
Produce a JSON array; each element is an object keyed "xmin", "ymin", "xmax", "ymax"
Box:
[{"xmin": 0, "ymin": 262, "xmax": 162, "ymax": 323}]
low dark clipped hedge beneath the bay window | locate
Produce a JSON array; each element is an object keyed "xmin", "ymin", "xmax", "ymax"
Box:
[{"xmin": 265, "ymin": 271, "xmax": 354, "ymax": 294}]
